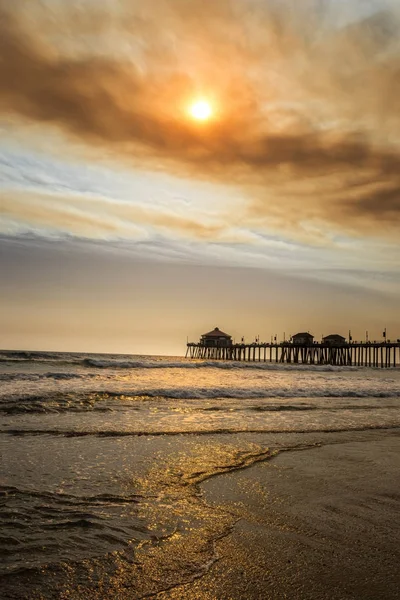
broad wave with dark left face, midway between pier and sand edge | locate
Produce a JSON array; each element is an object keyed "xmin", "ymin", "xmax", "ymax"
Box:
[{"xmin": 0, "ymin": 387, "xmax": 400, "ymax": 415}]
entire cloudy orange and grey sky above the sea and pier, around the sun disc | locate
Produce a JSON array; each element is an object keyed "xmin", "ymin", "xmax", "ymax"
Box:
[{"xmin": 0, "ymin": 0, "xmax": 400, "ymax": 355}]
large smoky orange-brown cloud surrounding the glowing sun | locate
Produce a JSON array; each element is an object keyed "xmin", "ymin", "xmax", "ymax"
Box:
[{"xmin": 0, "ymin": 0, "xmax": 400, "ymax": 241}]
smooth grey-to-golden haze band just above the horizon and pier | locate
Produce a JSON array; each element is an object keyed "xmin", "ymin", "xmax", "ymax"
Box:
[{"xmin": 0, "ymin": 240, "xmax": 400, "ymax": 355}]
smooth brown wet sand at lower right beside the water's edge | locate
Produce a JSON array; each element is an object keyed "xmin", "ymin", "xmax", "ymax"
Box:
[{"xmin": 156, "ymin": 431, "xmax": 400, "ymax": 600}]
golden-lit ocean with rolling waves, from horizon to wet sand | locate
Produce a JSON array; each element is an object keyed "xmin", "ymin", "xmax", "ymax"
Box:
[{"xmin": 0, "ymin": 351, "xmax": 400, "ymax": 599}]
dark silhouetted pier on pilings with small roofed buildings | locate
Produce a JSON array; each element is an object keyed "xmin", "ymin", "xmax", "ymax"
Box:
[{"xmin": 186, "ymin": 327, "xmax": 400, "ymax": 368}]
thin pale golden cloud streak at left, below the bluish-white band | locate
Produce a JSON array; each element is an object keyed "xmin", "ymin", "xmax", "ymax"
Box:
[{"xmin": 0, "ymin": 189, "xmax": 253, "ymax": 243}]
